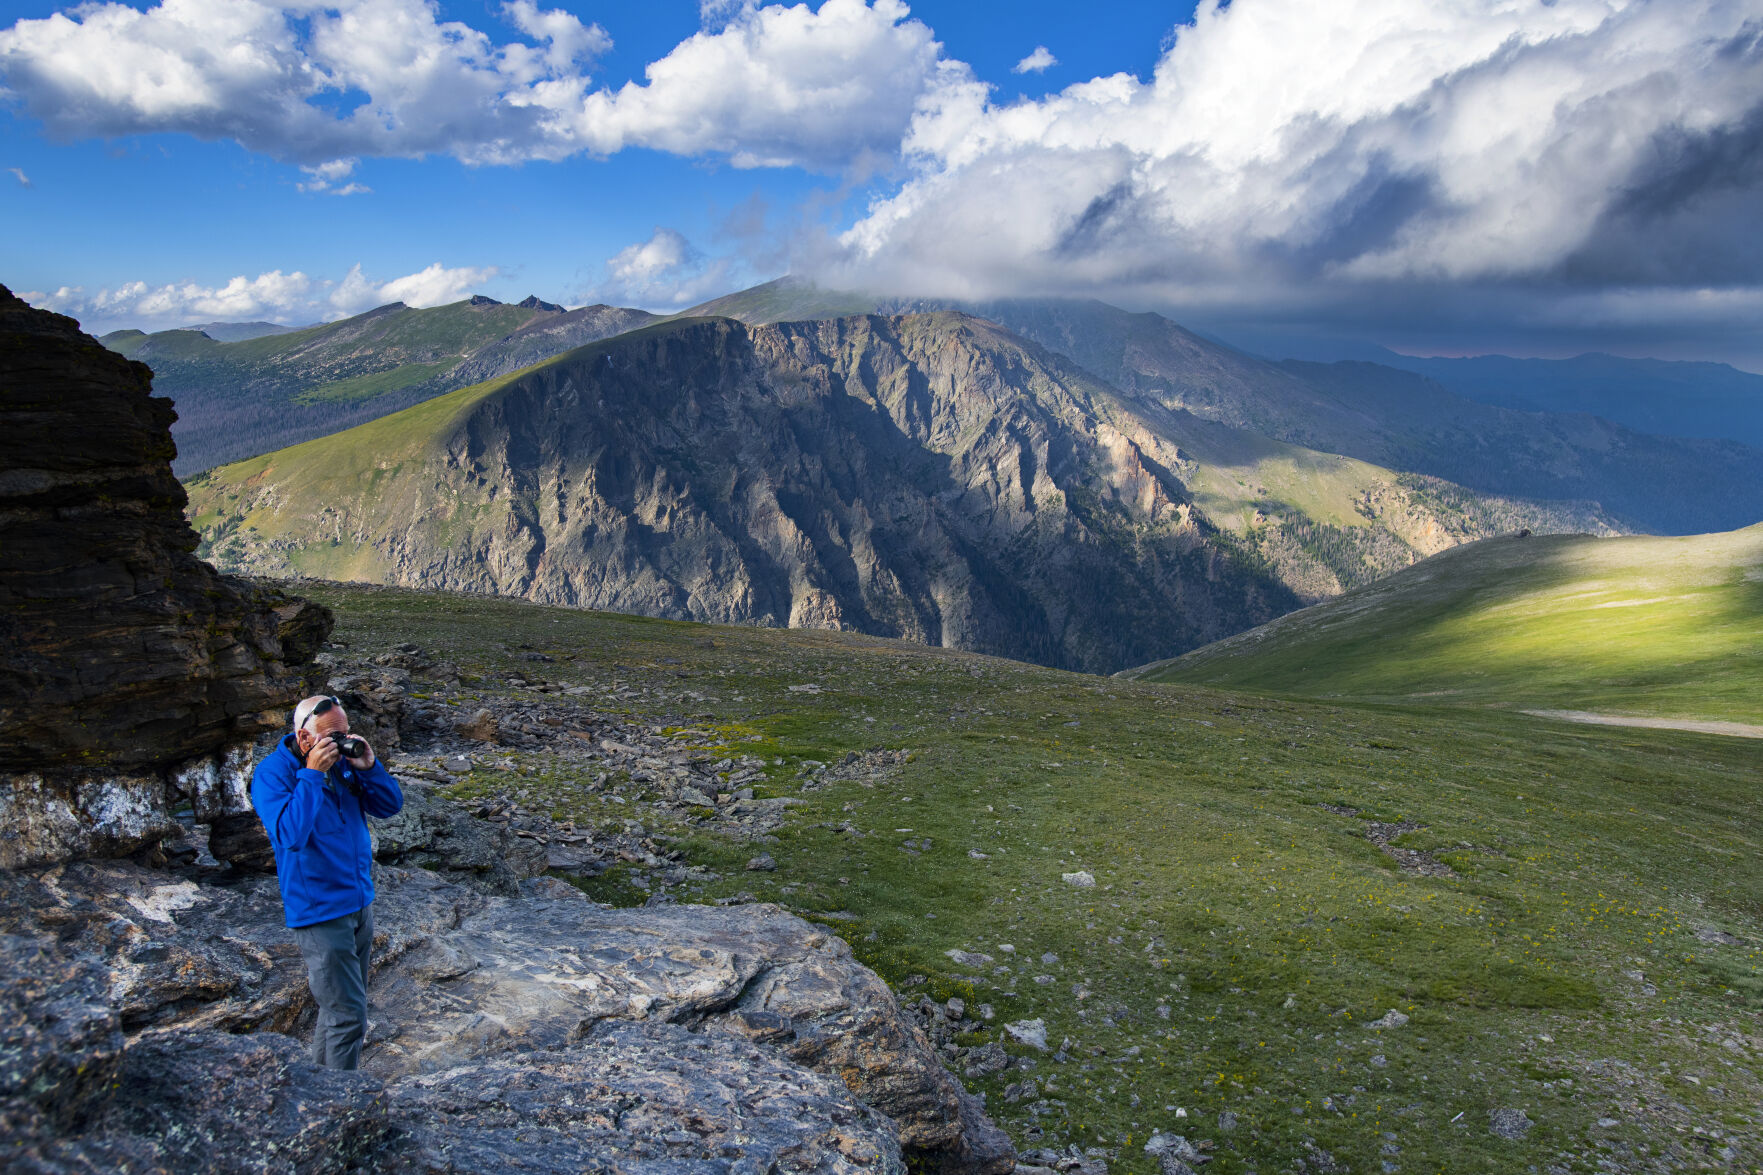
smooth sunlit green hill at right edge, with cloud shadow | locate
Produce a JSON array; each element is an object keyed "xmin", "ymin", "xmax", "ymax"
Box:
[{"xmin": 1132, "ymin": 524, "xmax": 1763, "ymax": 723}]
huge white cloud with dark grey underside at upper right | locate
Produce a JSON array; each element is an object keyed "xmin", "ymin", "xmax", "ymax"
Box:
[{"xmin": 822, "ymin": 0, "xmax": 1763, "ymax": 310}]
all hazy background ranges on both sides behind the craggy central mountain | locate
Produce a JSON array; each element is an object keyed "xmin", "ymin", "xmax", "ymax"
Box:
[{"xmin": 104, "ymin": 277, "xmax": 1763, "ymax": 533}]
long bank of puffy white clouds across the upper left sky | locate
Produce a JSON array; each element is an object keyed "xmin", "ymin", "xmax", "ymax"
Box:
[{"xmin": 0, "ymin": 0, "xmax": 941, "ymax": 172}]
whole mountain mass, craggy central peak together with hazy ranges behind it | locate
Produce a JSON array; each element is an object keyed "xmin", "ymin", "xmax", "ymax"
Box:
[{"xmin": 92, "ymin": 269, "xmax": 1763, "ymax": 670}]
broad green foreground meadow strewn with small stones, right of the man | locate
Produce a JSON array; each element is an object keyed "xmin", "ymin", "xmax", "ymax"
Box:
[{"xmin": 310, "ymin": 584, "xmax": 1763, "ymax": 1175}]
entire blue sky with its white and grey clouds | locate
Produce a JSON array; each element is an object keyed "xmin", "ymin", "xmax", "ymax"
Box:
[{"xmin": 0, "ymin": 0, "xmax": 1763, "ymax": 369}]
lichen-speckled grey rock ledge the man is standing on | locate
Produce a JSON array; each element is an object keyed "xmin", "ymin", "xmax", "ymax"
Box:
[{"xmin": 0, "ymin": 861, "xmax": 1014, "ymax": 1175}]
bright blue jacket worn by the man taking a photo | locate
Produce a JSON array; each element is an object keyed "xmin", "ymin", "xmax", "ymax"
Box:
[{"xmin": 250, "ymin": 734, "xmax": 404, "ymax": 928}]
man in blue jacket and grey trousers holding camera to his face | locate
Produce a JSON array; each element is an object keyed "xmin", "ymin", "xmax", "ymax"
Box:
[{"xmin": 250, "ymin": 695, "xmax": 404, "ymax": 1069}]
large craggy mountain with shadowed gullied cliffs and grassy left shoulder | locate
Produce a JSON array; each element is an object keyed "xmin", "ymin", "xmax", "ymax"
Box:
[{"xmin": 189, "ymin": 312, "xmax": 1611, "ymax": 670}]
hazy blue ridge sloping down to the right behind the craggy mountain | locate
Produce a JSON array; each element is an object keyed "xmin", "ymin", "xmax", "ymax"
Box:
[{"xmin": 686, "ymin": 279, "xmax": 1763, "ymax": 535}]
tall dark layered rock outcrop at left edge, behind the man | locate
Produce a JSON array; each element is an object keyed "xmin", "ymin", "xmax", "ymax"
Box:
[{"xmin": 0, "ymin": 288, "xmax": 331, "ymax": 864}]
